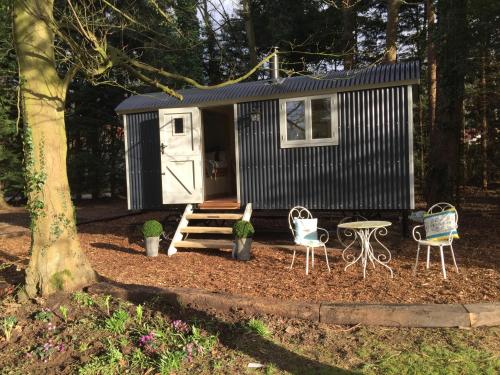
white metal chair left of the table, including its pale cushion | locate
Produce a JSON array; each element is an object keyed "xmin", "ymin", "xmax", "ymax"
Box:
[{"xmin": 288, "ymin": 206, "xmax": 330, "ymax": 275}]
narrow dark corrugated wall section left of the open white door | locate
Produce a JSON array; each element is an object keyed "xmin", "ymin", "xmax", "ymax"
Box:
[{"xmin": 126, "ymin": 111, "xmax": 162, "ymax": 210}]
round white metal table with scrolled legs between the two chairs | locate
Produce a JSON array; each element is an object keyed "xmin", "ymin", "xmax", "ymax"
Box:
[{"xmin": 338, "ymin": 220, "xmax": 394, "ymax": 278}]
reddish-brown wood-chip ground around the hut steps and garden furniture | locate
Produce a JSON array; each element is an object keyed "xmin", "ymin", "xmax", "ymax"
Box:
[{"xmin": 0, "ymin": 189, "xmax": 500, "ymax": 303}]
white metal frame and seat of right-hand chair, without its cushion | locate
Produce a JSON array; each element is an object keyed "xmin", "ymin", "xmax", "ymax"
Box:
[{"xmin": 413, "ymin": 202, "xmax": 458, "ymax": 279}]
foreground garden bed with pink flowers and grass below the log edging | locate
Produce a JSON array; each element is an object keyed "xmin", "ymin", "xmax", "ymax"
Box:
[{"xmin": 0, "ymin": 292, "xmax": 500, "ymax": 375}]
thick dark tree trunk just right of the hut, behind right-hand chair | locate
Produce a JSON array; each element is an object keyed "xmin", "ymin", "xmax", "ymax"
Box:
[{"xmin": 425, "ymin": 0, "xmax": 467, "ymax": 204}]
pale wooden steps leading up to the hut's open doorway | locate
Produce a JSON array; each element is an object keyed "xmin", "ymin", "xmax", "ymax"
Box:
[{"xmin": 168, "ymin": 203, "xmax": 252, "ymax": 256}]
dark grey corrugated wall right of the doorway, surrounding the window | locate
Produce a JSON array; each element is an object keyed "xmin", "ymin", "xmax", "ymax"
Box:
[{"xmin": 238, "ymin": 86, "xmax": 413, "ymax": 213}]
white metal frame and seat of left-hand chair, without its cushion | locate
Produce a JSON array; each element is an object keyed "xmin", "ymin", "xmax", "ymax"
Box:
[{"xmin": 288, "ymin": 206, "xmax": 330, "ymax": 275}]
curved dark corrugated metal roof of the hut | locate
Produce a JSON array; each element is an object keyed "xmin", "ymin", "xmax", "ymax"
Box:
[{"xmin": 116, "ymin": 61, "xmax": 420, "ymax": 113}]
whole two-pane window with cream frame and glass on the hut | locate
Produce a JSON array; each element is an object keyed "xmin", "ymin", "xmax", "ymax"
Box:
[{"xmin": 280, "ymin": 94, "xmax": 338, "ymax": 148}]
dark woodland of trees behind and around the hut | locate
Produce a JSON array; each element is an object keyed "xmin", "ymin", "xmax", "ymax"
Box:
[{"xmin": 0, "ymin": 0, "xmax": 500, "ymax": 203}]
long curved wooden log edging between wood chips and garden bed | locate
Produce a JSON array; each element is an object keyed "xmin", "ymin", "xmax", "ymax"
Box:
[{"xmin": 88, "ymin": 283, "xmax": 500, "ymax": 328}]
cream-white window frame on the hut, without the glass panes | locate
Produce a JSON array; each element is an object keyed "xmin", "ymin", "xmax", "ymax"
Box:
[{"xmin": 279, "ymin": 93, "xmax": 339, "ymax": 148}]
